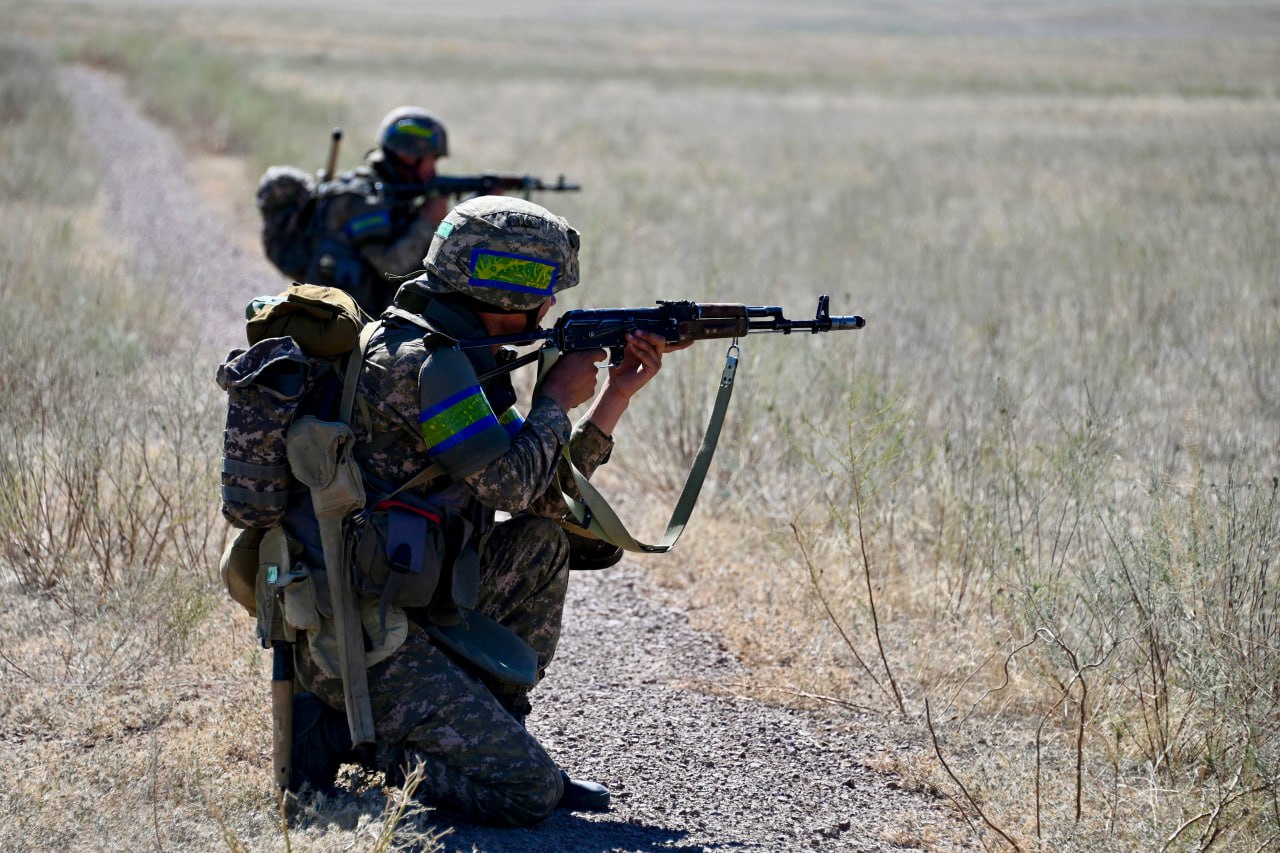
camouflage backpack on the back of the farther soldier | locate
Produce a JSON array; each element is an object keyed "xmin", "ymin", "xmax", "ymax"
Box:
[{"xmin": 255, "ymin": 165, "xmax": 317, "ymax": 280}]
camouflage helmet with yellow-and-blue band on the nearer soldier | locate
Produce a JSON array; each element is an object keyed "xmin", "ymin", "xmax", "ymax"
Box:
[{"xmin": 411, "ymin": 196, "xmax": 579, "ymax": 313}]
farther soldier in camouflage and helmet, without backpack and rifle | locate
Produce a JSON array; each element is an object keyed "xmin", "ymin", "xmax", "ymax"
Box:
[{"xmin": 302, "ymin": 106, "xmax": 449, "ymax": 316}]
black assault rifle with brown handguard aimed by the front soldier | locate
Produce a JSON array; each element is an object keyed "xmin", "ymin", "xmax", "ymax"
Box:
[{"xmin": 458, "ymin": 295, "xmax": 867, "ymax": 370}]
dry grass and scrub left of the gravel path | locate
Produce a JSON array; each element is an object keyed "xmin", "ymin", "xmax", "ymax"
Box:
[{"xmin": 0, "ymin": 38, "xmax": 450, "ymax": 850}]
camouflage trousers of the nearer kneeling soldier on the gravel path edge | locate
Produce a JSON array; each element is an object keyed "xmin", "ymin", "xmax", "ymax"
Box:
[{"xmin": 297, "ymin": 516, "xmax": 568, "ymax": 825}]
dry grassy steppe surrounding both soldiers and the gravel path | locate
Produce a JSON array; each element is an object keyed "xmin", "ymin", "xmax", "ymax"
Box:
[{"xmin": 0, "ymin": 0, "xmax": 1280, "ymax": 853}]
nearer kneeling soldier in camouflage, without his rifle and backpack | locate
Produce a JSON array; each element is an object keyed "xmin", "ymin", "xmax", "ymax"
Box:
[{"xmin": 287, "ymin": 196, "xmax": 667, "ymax": 825}]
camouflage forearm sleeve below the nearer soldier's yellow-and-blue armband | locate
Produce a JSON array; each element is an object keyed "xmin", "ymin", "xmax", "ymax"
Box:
[{"xmin": 462, "ymin": 397, "xmax": 570, "ymax": 514}]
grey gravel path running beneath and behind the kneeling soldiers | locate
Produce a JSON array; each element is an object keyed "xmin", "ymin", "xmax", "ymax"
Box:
[{"xmin": 63, "ymin": 68, "xmax": 965, "ymax": 852}]
